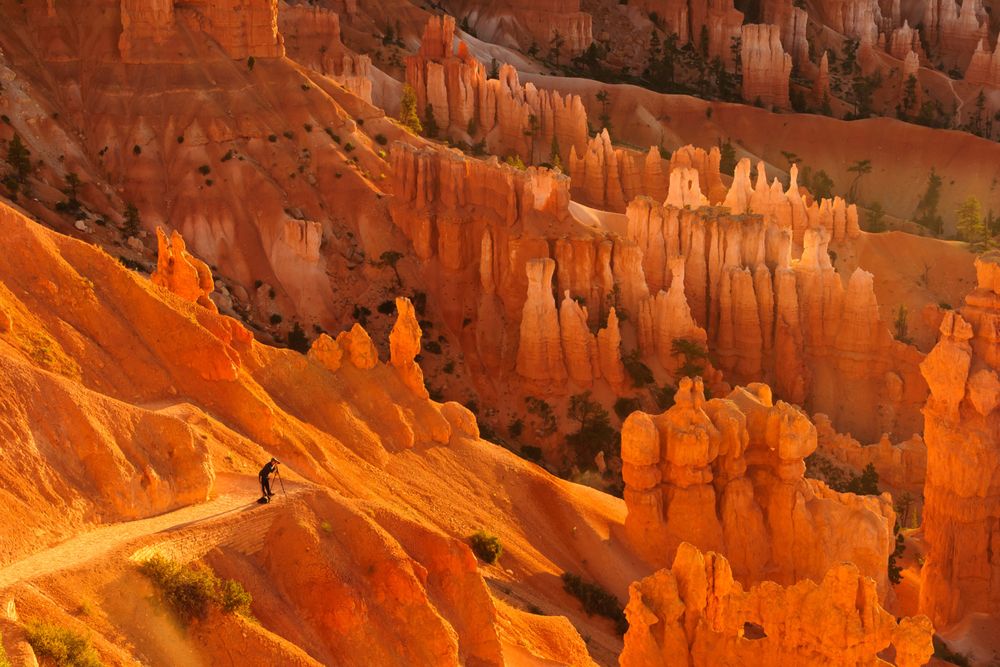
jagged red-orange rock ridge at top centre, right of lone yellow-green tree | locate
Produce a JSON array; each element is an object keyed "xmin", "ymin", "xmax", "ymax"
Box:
[{"xmin": 406, "ymin": 16, "xmax": 587, "ymax": 164}]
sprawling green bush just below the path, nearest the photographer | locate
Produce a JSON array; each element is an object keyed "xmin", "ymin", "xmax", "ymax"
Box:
[{"xmin": 139, "ymin": 556, "xmax": 253, "ymax": 623}]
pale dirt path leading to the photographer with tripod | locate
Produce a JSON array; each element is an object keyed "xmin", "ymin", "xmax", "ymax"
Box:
[{"xmin": 0, "ymin": 475, "xmax": 309, "ymax": 591}]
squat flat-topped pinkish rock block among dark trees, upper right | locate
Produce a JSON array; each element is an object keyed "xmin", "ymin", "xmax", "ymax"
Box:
[{"xmin": 740, "ymin": 24, "xmax": 792, "ymax": 109}]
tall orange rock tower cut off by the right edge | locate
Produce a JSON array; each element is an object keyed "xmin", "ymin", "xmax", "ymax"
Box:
[{"xmin": 920, "ymin": 251, "xmax": 1000, "ymax": 628}]
